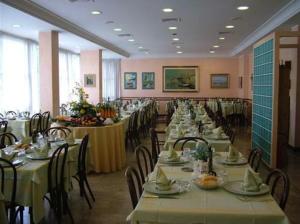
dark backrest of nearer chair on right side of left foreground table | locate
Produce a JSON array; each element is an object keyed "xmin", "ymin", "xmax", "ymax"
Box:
[{"xmin": 48, "ymin": 144, "xmax": 69, "ymax": 194}]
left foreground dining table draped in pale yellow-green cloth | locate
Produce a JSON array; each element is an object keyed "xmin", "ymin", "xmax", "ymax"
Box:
[{"xmin": 0, "ymin": 139, "xmax": 81, "ymax": 223}]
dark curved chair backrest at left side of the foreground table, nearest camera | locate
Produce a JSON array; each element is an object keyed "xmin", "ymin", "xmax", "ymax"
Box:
[{"xmin": 125, "ymin": 167, "xmax": 143, "ymax": 208}]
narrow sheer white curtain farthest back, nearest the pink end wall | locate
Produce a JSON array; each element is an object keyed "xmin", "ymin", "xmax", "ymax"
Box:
[{"xmin": 102, "ymin": 59, "xmax": 121, "ymax": 100}]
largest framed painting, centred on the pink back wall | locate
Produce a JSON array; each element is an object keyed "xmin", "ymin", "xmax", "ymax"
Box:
[{"xmin": 163, "ymin": 66, "xmax": 199, "ymax": 92}]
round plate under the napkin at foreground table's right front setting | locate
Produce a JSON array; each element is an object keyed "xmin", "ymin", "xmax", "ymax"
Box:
[{"xmin": 223, "ymin": 180, "xmax": 270, "ymax": 196}]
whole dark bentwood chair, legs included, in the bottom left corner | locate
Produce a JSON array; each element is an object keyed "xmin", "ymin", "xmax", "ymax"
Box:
[{"xmin": 0, "ymin": 158, "xmax": 23, "ymax": 224}]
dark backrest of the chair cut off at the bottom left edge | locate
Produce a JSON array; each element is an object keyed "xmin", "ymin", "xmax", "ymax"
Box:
[{"xmin": 0, "ymin": 158, "xmax": 17, "ymax": 223}]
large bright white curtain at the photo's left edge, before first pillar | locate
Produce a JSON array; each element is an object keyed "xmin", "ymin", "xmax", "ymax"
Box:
[{"xmin": 0, "ymin": 33, "xmax": 40, "ymax": 113}]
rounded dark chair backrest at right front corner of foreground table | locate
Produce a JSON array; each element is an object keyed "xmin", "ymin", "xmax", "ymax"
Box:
[{"xmin": 266, "ymin": 169, "xmax": 290, "ymax": 210}]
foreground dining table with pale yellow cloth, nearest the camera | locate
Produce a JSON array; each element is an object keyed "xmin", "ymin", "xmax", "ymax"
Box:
[{"xmin": 127, "ymin": 151, "xmax": 289, "ymax": 224}]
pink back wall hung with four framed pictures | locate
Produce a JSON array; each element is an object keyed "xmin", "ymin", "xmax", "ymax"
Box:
[{"xmin": 121, "ymin": 57, "xmax": 239, "ymax": 97}]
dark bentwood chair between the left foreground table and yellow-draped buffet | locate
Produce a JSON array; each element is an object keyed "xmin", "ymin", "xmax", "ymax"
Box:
[{"xmin": 73, "ymin": 135, "xmax": 95, "ymax": 209}]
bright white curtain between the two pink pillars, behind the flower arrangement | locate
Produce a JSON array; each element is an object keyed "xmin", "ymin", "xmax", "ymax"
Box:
[{"xmin": 59, "ymin": 50, "xmax": 80, "ymax": 104}]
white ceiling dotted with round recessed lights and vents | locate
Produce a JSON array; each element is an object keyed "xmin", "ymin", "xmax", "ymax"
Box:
[{"xmin": 0, "ymin": 0, "xmax": 300, "ymax": 57}]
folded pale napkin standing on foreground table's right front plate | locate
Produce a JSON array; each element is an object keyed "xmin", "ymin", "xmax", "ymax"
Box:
[{"xmin": 242, "ymin": 167, "xmax": 262, "ymax": 192}]
